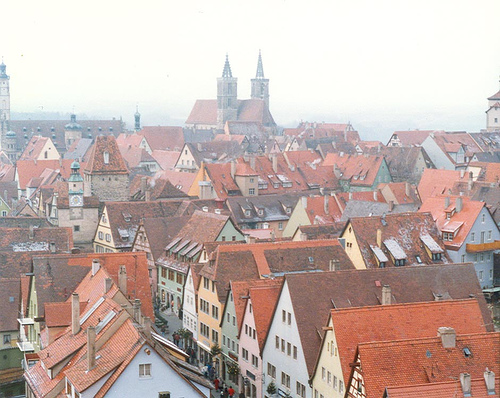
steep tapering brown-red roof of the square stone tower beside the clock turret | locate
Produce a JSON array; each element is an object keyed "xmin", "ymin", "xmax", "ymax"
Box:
[{"xmin": 84, "ymin": 135, "xmax": 128, "ymax": 174}]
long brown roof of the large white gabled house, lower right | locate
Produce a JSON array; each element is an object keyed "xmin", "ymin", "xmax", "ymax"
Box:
[{"xmin": 282, "ymin": 264, "xmax": 493, "ymax": 375}]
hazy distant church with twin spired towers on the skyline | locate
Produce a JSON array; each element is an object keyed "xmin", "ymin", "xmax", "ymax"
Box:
[{"xmin": 186, "ymin": 51, "xmax": 276, "ymax": 134}]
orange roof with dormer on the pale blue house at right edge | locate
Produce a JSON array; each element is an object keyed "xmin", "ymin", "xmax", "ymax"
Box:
[{"xmin": 419, "ymin": 196, "xmax": 485, "ymax": 250}]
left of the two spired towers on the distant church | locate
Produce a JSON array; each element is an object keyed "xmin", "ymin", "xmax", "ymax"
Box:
[{"xmin": 217, "ymin": 54, "xmax": 238, "ymax": 130}]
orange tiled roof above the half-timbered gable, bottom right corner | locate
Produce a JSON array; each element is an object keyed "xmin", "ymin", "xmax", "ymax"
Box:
[{"xmin": 358, "ymin": 333, "xmax": 500, "ymax": 397}]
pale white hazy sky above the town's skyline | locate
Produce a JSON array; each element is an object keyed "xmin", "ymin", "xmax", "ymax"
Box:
[{"xmin": 0, "ymin": 0, "xmax": 500, "ymax": 141}]
